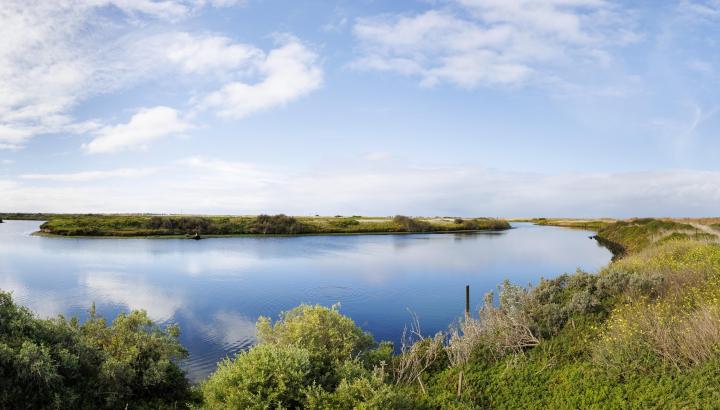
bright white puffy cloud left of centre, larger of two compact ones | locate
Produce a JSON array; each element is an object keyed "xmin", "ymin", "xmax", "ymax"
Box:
[{"xmin": 202, "ymin": 38, "xmax": 323, "ymax": 118}]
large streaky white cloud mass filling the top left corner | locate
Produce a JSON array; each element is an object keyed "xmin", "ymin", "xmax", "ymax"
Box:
[{"xmin": 0, "ymin": 0, "xmax": 248, "ymax": 149}]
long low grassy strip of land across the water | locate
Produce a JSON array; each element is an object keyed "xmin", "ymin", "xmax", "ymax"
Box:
[{"xmin": 32, "ymin": 215, "xmax": 510, "ymax": 237}]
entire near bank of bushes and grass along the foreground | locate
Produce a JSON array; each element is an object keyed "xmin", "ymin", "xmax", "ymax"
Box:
[{"xmin": 0, "ymin": 219, "xmax": 720, "ymax": 409}]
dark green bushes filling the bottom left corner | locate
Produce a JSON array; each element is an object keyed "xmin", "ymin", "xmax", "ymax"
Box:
[{"xmin": 0, "ymin": 292, "xmax": 189, "ymax": 409}]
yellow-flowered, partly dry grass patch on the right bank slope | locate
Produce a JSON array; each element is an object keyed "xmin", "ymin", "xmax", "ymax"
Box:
[{"xmin": 594, "ymin": 241, "xmax": 720, "ymax": 372}]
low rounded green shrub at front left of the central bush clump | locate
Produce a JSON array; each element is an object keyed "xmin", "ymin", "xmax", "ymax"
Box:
[{"xmin": 201, "ymin": 344, "xmax": 312, "ymax": 409}]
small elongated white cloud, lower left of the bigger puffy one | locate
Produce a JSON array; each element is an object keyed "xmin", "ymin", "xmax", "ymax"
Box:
[{"xmin": 83, "ymin": 106, "xmax": 190, "ymax": 154}]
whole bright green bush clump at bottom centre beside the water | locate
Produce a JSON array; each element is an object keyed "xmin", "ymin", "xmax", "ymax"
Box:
[{"xmin": 201, "ymin": 305, "xmax": 412, "ymax": 409}]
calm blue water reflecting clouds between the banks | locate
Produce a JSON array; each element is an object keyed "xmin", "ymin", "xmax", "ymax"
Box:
[{"xmin": 0, "ymin": 221, "xmax": 612, "ymax": 380}]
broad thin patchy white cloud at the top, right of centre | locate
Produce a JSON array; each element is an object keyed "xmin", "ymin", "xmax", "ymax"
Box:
[{"xmin": 353, "ymin": 0, "xmax": 637, "ymax": 88}]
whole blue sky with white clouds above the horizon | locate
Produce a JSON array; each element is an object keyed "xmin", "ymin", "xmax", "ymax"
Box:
[{"xmin": 0, "ymin": 0, "xmax": 720, "ymax": 217}]
